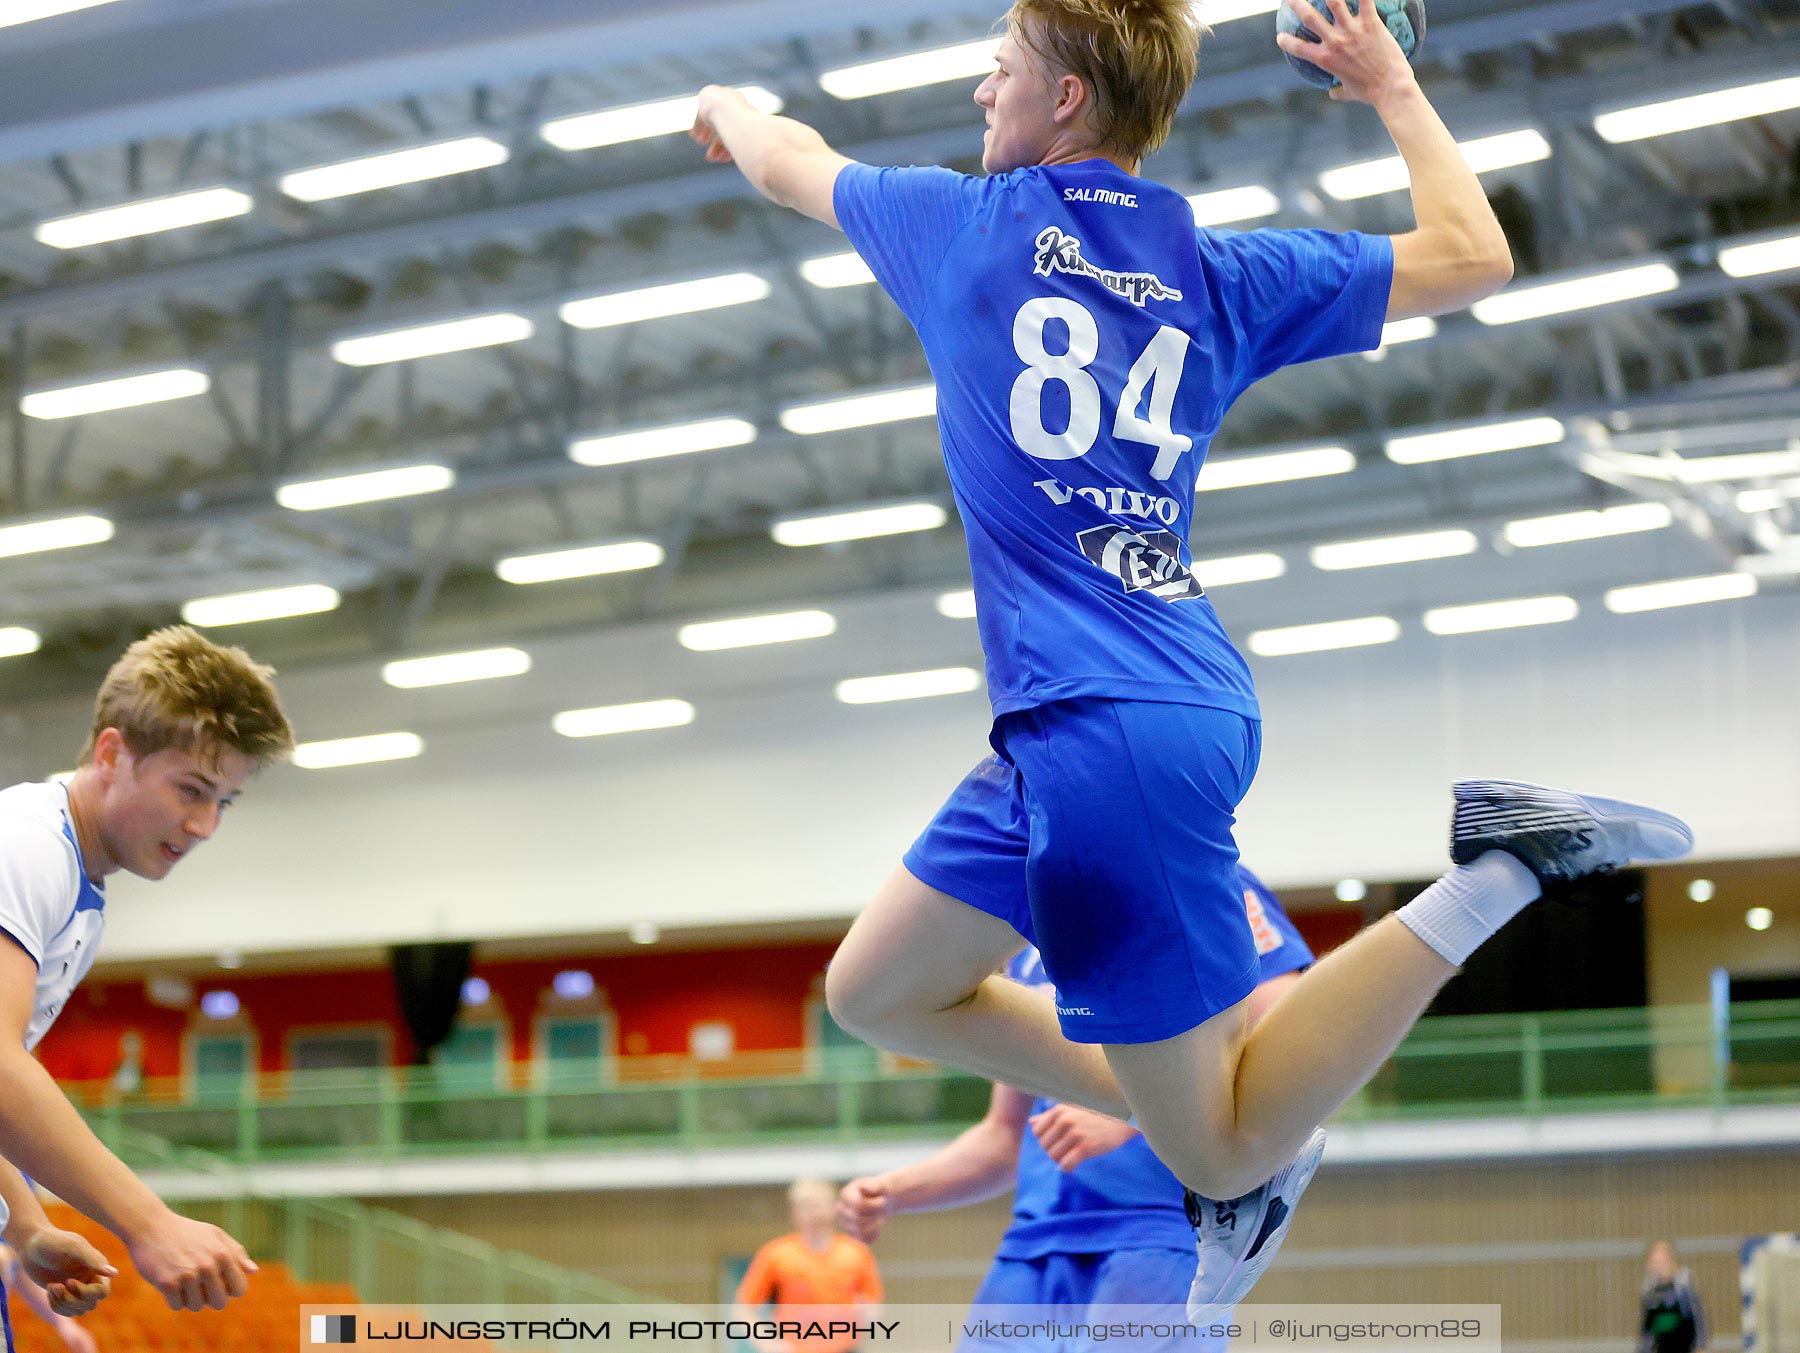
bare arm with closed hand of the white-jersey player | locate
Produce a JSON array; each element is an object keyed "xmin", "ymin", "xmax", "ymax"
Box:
[{"xmin": 0, "ymin": 939, "xmax": 256, "ymax": 1310}]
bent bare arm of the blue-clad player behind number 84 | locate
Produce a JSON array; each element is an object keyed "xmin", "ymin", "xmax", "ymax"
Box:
[{"xmin": 837, "ymin": 1085, "xmax": 1031, "ymax": 1241}]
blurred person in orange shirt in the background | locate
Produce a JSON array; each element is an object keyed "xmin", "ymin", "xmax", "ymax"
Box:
[{"xmin": 738, "ymin": 1178, "xmax": 882, "ymax": 1353}]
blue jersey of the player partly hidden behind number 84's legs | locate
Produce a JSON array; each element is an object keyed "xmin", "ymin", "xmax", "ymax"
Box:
[{"xmin": 997, "ymin": 865, "xmax": 1312, "ymax": 1259}]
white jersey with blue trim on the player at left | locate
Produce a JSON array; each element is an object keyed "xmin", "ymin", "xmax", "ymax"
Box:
[{"xmin": 0, "ymin": 784, "xmax": 106, "ymax": 1047}]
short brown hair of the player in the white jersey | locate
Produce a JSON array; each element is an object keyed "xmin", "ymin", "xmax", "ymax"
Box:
[{"xmin": 81, "ymin": 624, "xmax": 293, "ymax": 766}]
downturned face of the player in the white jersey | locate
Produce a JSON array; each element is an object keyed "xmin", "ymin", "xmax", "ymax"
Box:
[{"xmin": 94, "ymin": 729, "xmax": 256, "ymax": 878}]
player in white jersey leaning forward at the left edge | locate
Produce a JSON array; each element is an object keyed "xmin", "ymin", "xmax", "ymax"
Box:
[{"xmin": 0, "ymin": 628, "xmax": 293, "ymax": 1312}]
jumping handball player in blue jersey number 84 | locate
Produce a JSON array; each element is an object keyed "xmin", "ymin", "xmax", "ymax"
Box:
[{"xmin": 693, "ymin": 0, "xmax": 1692, "ymax": 1306}]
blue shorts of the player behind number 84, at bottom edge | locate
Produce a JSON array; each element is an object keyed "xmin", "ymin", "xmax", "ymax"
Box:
[{"xmin": 958, "ymin": 1249, "xmax": 1226, "ymax": 1353}]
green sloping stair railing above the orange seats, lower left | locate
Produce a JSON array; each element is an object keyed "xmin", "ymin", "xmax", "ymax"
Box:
[{"xmin": 108, "ymin": 1123, "xmax": 652, "ymax": 1306}]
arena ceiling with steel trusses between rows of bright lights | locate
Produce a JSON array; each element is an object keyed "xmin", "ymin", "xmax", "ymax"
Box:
[{"xmin": 0, "ymin": 0, "xmax": 1800, "ymax": 702}]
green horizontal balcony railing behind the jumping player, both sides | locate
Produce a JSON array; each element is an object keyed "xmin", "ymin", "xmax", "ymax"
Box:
[{"xmin": 76, "ymin": 1002, "xmax": 1800, "ymax": 1162}]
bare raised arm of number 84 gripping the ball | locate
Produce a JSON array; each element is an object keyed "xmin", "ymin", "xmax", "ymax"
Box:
[{"xmin": 1276, "ymin": 0, "xmax": 1512, "ymax": 320}]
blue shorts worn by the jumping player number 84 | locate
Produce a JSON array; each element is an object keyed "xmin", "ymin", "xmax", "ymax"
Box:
[{"xmin": 904, "ymin": 700, "xmax": 1262, "ymax": 1044}]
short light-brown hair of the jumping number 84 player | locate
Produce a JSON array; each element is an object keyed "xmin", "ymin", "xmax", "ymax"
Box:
[{"xmin": 1006, "ymin": 0, "xmax": 1206, "ymax": 158}]
